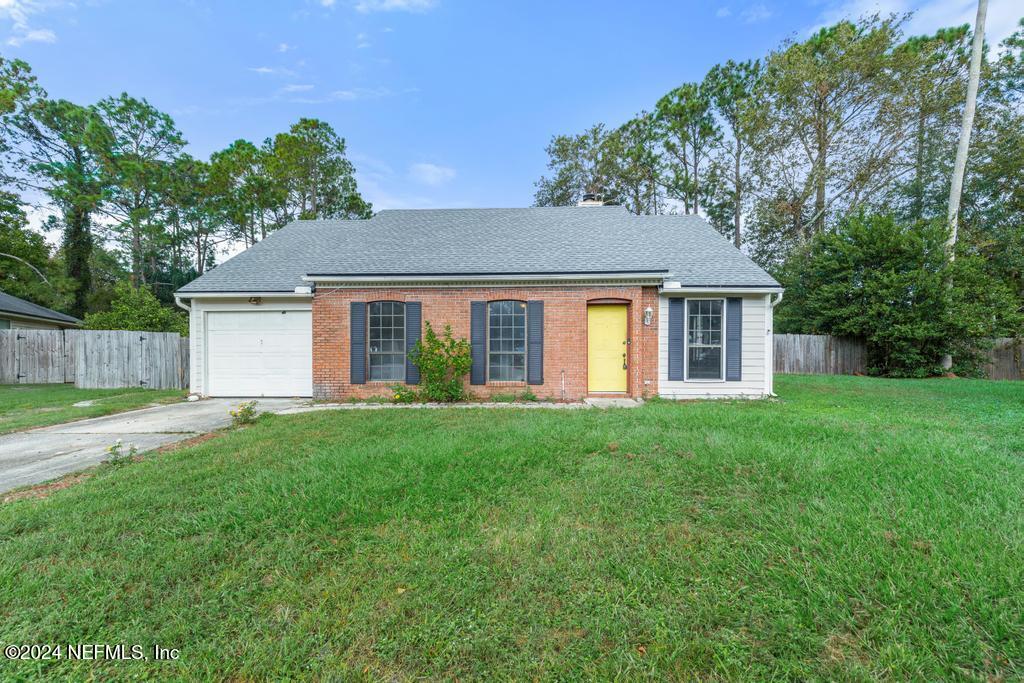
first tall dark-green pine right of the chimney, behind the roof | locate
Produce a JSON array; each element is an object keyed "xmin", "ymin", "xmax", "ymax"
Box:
[{"xmin": 655, "ymin": 83, "xmax": 721, "ymax": 213}]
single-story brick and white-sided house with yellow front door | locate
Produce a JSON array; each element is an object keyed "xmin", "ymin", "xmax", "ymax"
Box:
[{"xmin": 176, "ymin": 206, "xmax": 782, "ymax": 400}]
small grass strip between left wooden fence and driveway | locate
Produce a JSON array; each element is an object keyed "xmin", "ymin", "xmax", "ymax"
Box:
[{"xmin": 0, "ymin": 384, "xmax": 184, "ymax": 434}]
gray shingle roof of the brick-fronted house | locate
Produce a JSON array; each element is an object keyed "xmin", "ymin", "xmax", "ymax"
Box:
[{"xmin": 179, "ymin": 207, "xmax": 778, "ymax": 294}]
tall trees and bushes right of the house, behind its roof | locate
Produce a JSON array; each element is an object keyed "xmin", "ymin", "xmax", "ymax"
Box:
[{"xmin": 535, "ymin": 15, "xmax": 1024, "ymax": 375}]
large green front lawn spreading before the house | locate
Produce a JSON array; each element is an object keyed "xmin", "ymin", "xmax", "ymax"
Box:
[{"xmin": 0, "ymin": 377, "xmax": 1024, "ymax": 680}]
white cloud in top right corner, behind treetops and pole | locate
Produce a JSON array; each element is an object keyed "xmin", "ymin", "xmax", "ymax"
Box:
[{"xmin": 811, "ymin": 0, "xmax": 1021, "ymax": 47}]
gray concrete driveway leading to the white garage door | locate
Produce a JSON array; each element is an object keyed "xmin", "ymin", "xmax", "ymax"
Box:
[{"xmin": 0, "ymin": 398, "xmax": 309, "ymax": 493}]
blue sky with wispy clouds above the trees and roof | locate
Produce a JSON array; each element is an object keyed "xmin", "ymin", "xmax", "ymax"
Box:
[{"xmin": 0, "ymin": 0, "xmax": 1024, "ymax": 214}]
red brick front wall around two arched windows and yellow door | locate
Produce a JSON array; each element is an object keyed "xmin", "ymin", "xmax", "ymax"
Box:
[{"xmin": 313, "ymin": 287, "xmax": 657, "ymax": 400}]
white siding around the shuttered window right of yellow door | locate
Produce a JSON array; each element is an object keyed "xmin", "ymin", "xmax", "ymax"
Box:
[{"xmin": 657, "ymin": 293, "xmax": 771, "ymax": 398}]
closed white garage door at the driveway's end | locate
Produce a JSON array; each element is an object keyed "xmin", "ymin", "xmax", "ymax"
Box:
[{"xmin": 206, "ymin": 310, "xmax": 313, "ymax": 396}]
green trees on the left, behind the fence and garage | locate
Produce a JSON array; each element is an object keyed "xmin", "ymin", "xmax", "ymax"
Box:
[{"xmin": 0, "ymin": 57, "xmax": 372, "ymax": 319}]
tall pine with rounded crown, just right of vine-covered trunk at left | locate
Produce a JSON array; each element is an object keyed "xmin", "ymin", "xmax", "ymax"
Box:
[{"xmin": 95, "ymin": 93, "xmax": 185, "ymax": 287}]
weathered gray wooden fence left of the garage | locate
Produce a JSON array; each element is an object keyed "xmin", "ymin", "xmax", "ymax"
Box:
[{"xmin": 0, "ymin": 330, "xmax": 188, "ymax": 389}]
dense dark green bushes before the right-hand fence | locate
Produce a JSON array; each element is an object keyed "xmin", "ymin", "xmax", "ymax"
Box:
[{"xmin": 776, "ymin": 216, "xmax": 1021, "ymax": 377}]
